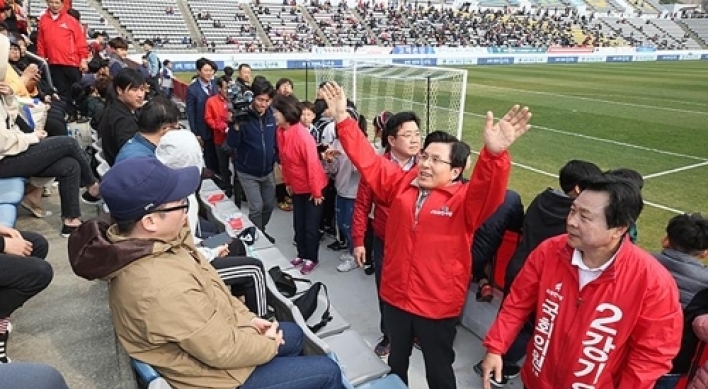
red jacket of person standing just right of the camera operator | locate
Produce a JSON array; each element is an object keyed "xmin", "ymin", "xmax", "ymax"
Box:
[{"xmin": 276, "ymin": 123, "xmax": 327, "ymax": 198}]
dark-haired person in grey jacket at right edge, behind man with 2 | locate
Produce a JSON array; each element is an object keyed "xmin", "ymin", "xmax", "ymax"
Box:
[{"xmin": 654, "ymin": 213, "xmax": 708, "ymax": 389}]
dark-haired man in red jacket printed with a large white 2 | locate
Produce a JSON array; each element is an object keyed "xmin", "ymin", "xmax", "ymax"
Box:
[{"xmin": 481, "ymin": 174, "xmax": 683, "ymax": 389}]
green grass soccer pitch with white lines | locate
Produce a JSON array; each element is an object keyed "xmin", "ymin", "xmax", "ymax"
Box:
[{"xmin": 178, "ymin": 61, "xmax": 708, "ymax": 250}]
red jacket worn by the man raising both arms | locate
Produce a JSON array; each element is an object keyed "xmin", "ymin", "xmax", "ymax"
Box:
[{"xmin": 337, "ymin": 119, "xmax": 511, "ymax": 319}]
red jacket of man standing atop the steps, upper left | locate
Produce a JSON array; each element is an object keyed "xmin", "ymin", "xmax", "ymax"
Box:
[{"xmin": 37, "ymin": 9, "xmax": 89, "ymax": 67}]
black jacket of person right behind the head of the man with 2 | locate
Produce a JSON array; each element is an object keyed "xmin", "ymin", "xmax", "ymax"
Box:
[{"xmin": 504, "ymin": 188, "xmax": 573, "ymax": 292}]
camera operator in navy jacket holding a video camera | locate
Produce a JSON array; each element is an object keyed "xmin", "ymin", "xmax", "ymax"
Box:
[{"xmin": 226, "ymin": 80, "xmax": 278, "ymax": 241}]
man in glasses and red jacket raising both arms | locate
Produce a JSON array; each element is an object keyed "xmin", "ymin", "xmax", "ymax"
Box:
[{"xmin": 323, "ymin": 83, "xmax": 531, "ymax": 389}]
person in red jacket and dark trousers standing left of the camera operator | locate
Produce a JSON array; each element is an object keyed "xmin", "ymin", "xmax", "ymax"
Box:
[{"xmin": 204, "ymin": 77, "xmax": 235, "ymax": 197}]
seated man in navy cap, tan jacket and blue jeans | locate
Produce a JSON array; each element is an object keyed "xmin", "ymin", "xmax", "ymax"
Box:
[{"xmin": 69, "ymin": 158, "xmax": 343, "ymax": 389}]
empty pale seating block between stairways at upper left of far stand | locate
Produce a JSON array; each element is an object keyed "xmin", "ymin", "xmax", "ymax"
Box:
[{"xmin": 102, "ymin": 0, "xmax": 193, "ymax": 52}]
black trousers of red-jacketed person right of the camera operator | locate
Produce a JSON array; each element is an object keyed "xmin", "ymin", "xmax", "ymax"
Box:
[{"xmin": 293, "ymin": 194, "xmax": 323, "ymax": 262}]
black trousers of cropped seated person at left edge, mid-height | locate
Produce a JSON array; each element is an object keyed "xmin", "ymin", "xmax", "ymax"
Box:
[{"xmin": 0, "ymin": 231, "xmax": 54, "ymax": 319}]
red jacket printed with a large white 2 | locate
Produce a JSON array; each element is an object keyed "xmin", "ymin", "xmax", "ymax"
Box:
[{"xmin": 483, "ymin": 235, "xmax": 683, "ymax": 389}]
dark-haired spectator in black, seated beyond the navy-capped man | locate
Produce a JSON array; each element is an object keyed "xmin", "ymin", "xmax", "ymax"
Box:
[{"xmin": 98, "ymin": 68, "xmax": 145, "ymax": 166}]
